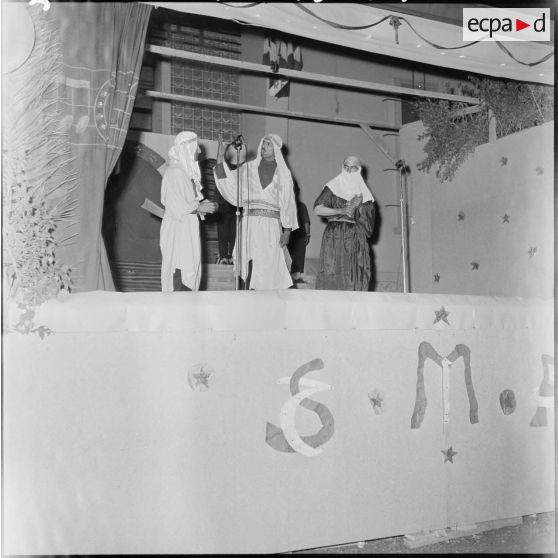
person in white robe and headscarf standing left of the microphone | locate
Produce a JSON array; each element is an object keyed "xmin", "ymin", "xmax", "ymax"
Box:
[{"xmin": 160, "ymin": 132, "xmax": 215, "ymax": 292}]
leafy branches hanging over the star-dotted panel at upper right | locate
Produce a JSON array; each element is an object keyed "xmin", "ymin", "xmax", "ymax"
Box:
[{"xmin": 413, "ymin": 76, "xmax": 554, "ymax": 182}]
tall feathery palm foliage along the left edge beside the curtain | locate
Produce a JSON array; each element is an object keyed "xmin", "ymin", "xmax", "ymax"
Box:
[{"xmin": 2, "ymin": 10, "xmax": 76, "ymax": 337}]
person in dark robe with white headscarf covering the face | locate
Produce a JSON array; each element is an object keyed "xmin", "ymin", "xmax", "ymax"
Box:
[{"xmin": 314, "ymin": 156, "xmax": 376, "ymax": 291}]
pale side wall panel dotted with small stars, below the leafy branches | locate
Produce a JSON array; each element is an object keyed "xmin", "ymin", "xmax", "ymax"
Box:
[{"xmin": 400, "ymin": 122, "xmax": 554, "ymax": 297}]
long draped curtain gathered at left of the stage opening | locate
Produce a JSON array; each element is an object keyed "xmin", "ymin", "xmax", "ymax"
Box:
[{"xmin": 49, "ymin": 2, "xmax": 152, "ymax": 291}]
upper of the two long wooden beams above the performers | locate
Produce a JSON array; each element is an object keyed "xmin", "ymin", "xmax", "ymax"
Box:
[{"xmin": 145, "ymin": 45, "xmax": 480, "ymax": 105}]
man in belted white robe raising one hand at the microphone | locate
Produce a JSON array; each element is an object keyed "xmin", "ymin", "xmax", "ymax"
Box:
[{"xmin": 214, "ymin": 134, "xmax": 298, "ymax": 290}]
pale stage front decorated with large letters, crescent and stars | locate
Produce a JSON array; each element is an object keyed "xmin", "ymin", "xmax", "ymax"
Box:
[{"xmin": 3, "ymin": 289, "xmax": 555, "ymax": 555}]
